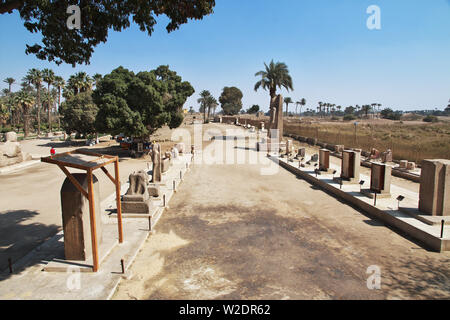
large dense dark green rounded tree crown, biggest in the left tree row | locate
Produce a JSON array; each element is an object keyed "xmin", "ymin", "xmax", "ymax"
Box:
[{"xmin": 93, "ymin": 66, "xmax": 194, "ymax": 137}]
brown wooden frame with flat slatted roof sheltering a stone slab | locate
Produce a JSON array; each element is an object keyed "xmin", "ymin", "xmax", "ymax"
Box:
[{"xmin": 41, "ymin": 149, "xmax": 123, "ymax": 272}]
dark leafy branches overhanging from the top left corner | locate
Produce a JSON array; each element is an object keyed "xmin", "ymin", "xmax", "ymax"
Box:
[{"xmin": 0, "ymin": 0, "xmax": 215, "ymax": 65}]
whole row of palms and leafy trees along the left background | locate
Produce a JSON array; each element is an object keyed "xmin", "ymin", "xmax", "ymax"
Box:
[{"xmin": 0, "ymin": 66, "xmax": 194, "ymax": 137}]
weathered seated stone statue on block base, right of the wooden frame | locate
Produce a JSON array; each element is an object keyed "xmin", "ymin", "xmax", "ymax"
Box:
[{"xmin": 122, "ymin": 171, "xmax": 152, "ymax": 214}]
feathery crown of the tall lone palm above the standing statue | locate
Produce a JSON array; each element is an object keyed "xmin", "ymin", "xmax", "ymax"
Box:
[{"xmin": 255, "ymin": 60, "xmax": 294, "ymax": 112}]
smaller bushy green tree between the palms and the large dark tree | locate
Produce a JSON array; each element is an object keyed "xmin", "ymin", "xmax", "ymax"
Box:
[{"xmin": 59, "ymin": 92, "xmax": 98, "ymax": 135}]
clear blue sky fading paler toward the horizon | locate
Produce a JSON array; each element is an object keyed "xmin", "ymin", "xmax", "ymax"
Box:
[{"xmin": 0, "ymin": 0, "xmax": 450, "ymax": 110}]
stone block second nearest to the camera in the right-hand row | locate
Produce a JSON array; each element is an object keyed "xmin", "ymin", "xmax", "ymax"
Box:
[{"xmin": 362, "ymin": 162, "xmax": 392, "ymax": 198}]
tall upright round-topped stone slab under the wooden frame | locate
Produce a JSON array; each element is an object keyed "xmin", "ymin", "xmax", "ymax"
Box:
[{"xmin": 61, "ymin": 173, "xmax": 102, "ymax": 261}]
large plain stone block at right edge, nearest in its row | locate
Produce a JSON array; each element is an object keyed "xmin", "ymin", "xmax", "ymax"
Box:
[{"xmin": 419, "ymin": 159, "xmax": 450, "ymax": 216}]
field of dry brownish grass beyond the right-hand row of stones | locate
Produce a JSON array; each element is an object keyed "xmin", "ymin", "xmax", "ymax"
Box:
[{"xmin": 284, "ymin": 121, "xmax": 450, "ymax": 163}]
